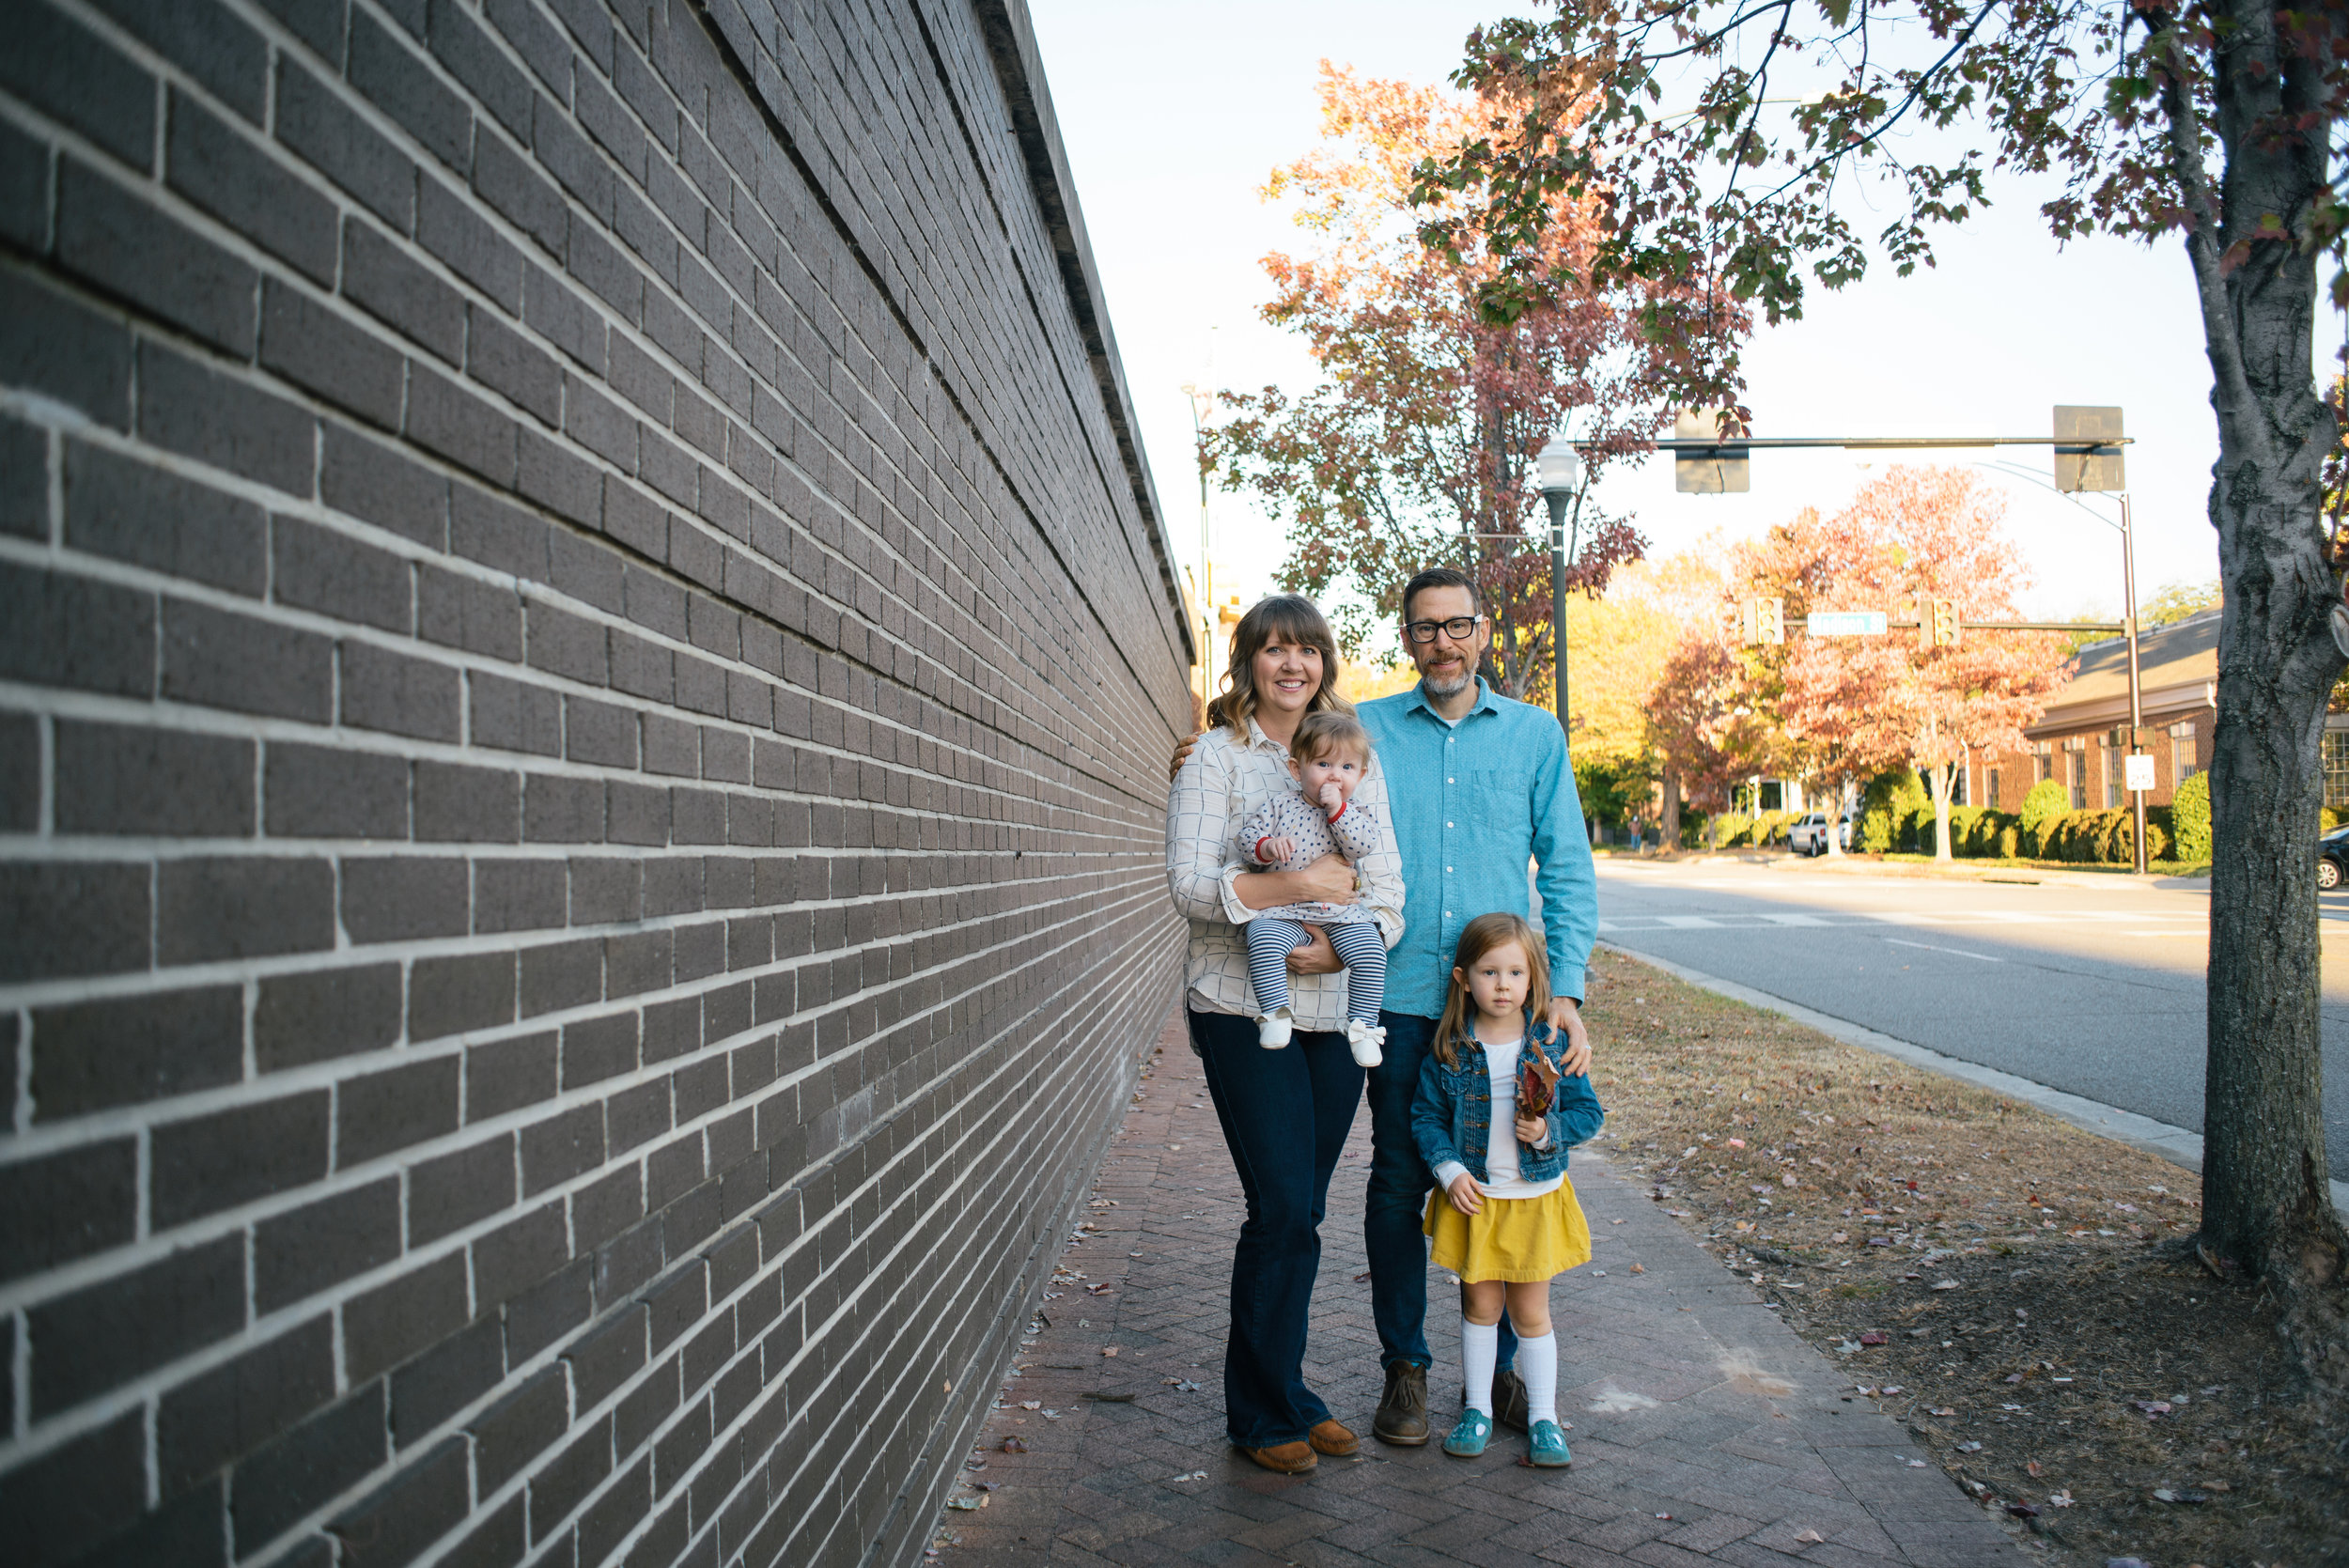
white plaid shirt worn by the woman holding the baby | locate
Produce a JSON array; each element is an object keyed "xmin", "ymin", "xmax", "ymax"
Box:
[{"xmin": 1168, "ymin": 719, "xmax": 1403, "ymax": 1031}]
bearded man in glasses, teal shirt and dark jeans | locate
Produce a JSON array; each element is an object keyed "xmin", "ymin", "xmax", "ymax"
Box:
[{"xmin": 1325, "ymin": 566, "xmax": 1597, "ymax": 1446}]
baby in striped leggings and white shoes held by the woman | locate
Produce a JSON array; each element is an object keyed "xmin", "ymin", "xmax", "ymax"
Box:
[{"xmin": 1240, "ymin": 711, "xmax": 1386, "ymax": 1068}]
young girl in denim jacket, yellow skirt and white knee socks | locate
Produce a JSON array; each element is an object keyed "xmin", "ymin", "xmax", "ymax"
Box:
[{"xmin": 1412, "ymin": 913, "xmax": 1605, "ymax": 1467}]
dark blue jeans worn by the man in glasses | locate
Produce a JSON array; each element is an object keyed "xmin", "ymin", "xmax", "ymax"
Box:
[{"xmin": 1362, "ymin": 1012, "xmax": 1517, "ymax": 1371}]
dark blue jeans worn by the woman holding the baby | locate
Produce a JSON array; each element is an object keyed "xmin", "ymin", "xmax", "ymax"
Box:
[{"xmin": 1187, "ymin": 1009, "xmax": 1362, "ymax": 1449}]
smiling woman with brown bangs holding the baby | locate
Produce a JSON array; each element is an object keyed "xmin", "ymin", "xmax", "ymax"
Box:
[{"xmin": 1168, "ymin": 594, "xmax": 1403, "ymax": 1474}]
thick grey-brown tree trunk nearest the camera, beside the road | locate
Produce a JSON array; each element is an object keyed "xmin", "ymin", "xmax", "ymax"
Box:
[{"xmin": 2169, "ymin": 0, "xmax": 2349, "ymax": 1284}]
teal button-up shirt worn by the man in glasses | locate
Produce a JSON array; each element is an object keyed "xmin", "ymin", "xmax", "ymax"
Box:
[{"xmin": 1358, "ymin": 681, "xmax": 1600, "ymax": 1018}]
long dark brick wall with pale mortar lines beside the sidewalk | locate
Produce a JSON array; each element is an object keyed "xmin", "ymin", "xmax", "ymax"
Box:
[{"xmin": 0, "ymin": 0, "xmax": 1193, "ymax": 1568}]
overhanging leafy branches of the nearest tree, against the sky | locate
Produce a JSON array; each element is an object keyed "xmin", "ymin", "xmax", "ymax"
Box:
[{"xmin": 1414, "ymin": 0, "xmax": 2264, "ymax": 415}]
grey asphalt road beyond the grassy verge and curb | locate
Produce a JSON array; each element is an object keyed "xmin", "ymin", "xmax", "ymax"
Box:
[{"xmin": 1600, "ymin": 857, "xmax": 2349, "ymax": 1178}]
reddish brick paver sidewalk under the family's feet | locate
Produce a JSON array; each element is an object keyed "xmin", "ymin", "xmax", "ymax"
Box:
[{"xmin": 938, "ymin": 1023, "xmax": 2025, "ymax": 1568}]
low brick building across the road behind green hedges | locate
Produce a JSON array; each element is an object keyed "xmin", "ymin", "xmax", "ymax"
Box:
[{"xmin": 1967, "ymin": 611, "xmax": 2220, "ymax": 812}]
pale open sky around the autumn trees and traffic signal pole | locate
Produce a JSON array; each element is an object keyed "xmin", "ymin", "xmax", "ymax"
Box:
[{"xmin": 1029, "ymin": 0, "xmax": 2246, "ymax": 647}]
